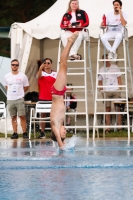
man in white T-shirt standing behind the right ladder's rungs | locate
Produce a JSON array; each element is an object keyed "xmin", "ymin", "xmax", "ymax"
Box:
[{"xmin": 98, "ymin": 54, "xmax": 122, "ymax": 133}]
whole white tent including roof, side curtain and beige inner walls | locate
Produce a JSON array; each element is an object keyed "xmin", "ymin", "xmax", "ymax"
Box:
[{"xmin": 10, "ymin": 0, "xmax": 133, "ymax": 113}]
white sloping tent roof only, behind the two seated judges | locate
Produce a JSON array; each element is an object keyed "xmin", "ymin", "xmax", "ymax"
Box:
[{"xmin": 12, "ymin": 0, "xmax": 133, "ymax": 39}]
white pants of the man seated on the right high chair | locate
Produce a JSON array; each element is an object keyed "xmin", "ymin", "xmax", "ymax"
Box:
[{"xmin": 101, "ymin": 31, "xmax": 123, "ymax": 53}]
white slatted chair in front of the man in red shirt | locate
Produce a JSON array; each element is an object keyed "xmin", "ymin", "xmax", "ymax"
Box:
[{"xmin": 29, "ymin": 101, "xmax": 52, "ymax": 139}]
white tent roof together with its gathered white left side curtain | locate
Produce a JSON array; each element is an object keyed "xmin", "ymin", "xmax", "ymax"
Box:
[{"xmin": 10, "ymin": 0, "xmax": 133, "ymax": 67}]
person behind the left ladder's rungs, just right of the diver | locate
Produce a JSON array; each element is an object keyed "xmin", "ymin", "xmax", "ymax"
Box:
[{"xmin": 66, "ymin": 84, "xmax": 77, "ymax": 133}]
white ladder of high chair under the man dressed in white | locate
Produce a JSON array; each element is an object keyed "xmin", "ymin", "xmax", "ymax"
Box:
[{"xmin": 93, "ymin": 28, "xmax": 133, "ymax": 140}]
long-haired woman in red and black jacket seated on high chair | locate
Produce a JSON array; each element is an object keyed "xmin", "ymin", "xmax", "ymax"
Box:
[{"xmin": 60, "ymin": 0, "xmax": 89, "ymax": 60}]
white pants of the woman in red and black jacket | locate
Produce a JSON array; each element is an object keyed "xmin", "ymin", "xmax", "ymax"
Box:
[{"xmin": 61, "ymin": 30, "xmax": 86, "ymax": 56}]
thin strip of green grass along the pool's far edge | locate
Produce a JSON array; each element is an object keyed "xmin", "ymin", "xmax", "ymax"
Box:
[{"xmin": 0, "ymin": 130, "xmax": 133, "ymax": 139}]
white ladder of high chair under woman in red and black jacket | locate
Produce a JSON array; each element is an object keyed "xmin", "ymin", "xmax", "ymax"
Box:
[{"xmin": 57, "ymin": 31, "xmax": 94, "ymax": 140}]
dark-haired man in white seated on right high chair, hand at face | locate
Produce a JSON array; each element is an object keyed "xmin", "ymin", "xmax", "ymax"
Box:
[{"xmin": 101, "ymin": 0, "xmax": 127, "ymax": 59}]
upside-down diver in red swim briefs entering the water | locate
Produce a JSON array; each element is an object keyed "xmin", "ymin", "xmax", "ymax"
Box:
[{"xmin": 50, "ymin": 31, "xmax": 78, "ymax": 149}]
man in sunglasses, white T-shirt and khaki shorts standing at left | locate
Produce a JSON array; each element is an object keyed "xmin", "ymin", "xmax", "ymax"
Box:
[{"xmin": 4, "ymin": 59, "xmax": 29, "ymax": 139}]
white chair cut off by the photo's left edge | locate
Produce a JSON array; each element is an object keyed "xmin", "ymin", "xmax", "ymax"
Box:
[{"xmin": 0, "ymin": 101, "xmax": 7, "ymax": 139}]
